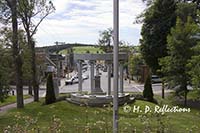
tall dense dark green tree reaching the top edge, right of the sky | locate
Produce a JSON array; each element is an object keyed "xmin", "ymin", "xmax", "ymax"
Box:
[{"xmin": 140, "ymin": 0, "xmax": 176, "ymax": 73}]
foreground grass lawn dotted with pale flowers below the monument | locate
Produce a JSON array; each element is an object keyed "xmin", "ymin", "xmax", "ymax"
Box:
[{"xmin": 0, "ymin": 93, "xmax": 200, "ymax": 133}]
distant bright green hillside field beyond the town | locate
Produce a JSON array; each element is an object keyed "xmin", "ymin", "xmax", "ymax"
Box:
[{"xmin": 59, "ymin": 46, "xmax": 103, "ymax": 54}]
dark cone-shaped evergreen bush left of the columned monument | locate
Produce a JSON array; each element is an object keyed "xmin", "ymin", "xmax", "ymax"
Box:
[{"xmin": 45, "ymin": 73, "xmax": 56, "ymax": 104}]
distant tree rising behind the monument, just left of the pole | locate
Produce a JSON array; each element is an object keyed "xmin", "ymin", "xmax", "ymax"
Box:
[{"xmin": 98, "ymin": 28, "xmax": 113, "ymax": 53}]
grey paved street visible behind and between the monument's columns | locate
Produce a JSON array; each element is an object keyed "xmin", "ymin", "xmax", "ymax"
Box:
[{"xmin": 11, "ymin": 66, "xmax": 171, "ymax": 97}]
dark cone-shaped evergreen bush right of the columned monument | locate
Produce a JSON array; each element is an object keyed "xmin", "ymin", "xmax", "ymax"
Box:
[{"xmin": 143, "ymin": 74, "xmax": 153, "ymax": 101}]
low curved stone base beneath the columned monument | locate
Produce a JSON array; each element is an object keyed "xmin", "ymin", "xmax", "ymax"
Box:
[{"xmin": 67, "ymin": 93, "xmax": 135, "ymax": 107}]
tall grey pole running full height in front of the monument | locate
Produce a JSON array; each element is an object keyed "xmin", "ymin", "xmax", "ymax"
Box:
[{"xmin": 113, "ymin": 0, "xmax": 119, "ymax": 133}]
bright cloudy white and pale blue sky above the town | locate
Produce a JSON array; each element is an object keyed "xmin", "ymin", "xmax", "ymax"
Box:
[{"xmin": 34, "ymin": 0, "xmax": 145, "ymax": 47}]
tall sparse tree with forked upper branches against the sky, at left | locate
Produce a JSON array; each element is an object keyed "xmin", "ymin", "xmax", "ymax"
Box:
[{"xmin": 18, "ymin": 0, "xmax": 55, "ymax": 101}]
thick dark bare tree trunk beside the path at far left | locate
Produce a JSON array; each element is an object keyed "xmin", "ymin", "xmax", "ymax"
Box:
[{"xmin": 10, "ymin": 0, "xmax": 24, "ymax": 108}]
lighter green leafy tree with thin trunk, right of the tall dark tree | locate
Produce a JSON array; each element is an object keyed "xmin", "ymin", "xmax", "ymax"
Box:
[{"xmin": 160, "ymin": 16, "xmax": 199, "ymax": 105}]
